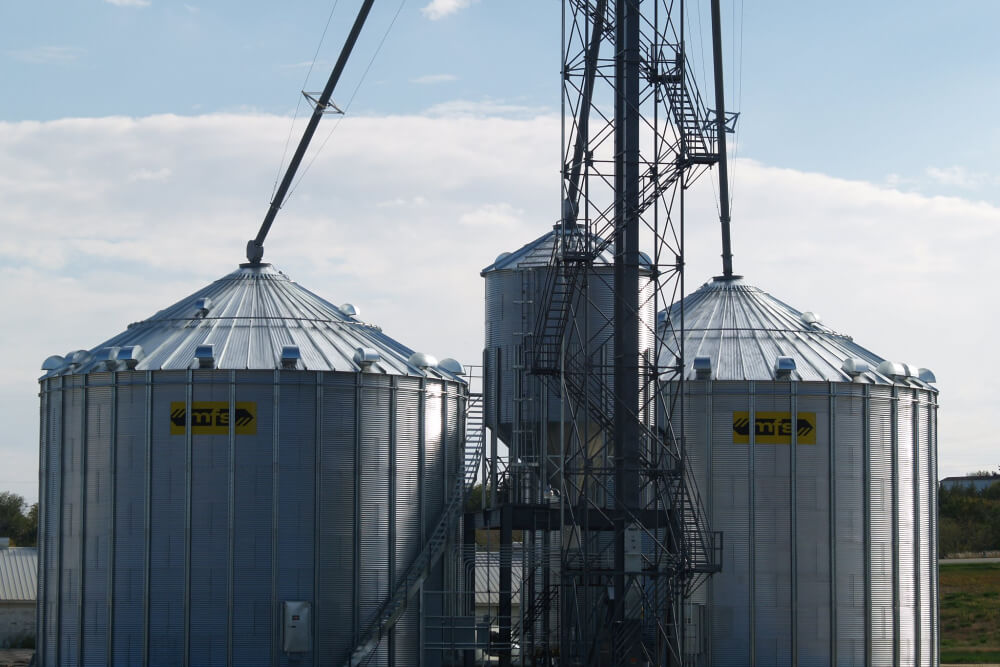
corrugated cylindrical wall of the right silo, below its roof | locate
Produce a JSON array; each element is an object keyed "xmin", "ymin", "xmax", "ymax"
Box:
[{"xmin": 685, "ymin": 381, "xmax": 939, "ymax": 665}]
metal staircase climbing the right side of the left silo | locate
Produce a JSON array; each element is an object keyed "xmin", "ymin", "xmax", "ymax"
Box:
[{"xmin": 344, "ymin": 393, "xmax": 486, "ymax": 667}]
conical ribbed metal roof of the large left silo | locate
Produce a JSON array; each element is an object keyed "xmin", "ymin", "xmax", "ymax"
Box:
[{"xmin": 40, "ymin": 264, "xmax": 456, "ymax": 379}]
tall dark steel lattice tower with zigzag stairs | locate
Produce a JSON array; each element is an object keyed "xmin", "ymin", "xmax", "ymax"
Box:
[{"xmin": 480, "ymin": 0, "xmax": 724, "ymax": 665}]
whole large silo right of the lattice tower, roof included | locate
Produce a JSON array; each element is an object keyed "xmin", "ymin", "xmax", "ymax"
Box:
[{"xmin": 664, "ymin": 277, "xmax": 939, "ymax": 667}]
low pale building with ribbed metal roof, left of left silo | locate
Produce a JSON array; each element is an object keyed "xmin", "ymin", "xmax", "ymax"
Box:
[{"xmin": 0, "ymin": 537, "xmax": 38, "ymax": 647}]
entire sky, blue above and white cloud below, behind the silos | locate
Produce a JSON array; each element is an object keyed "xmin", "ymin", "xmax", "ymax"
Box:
[{"xmin": 0, "ymin": 0, "xmax": 1000, "ymax": 498}]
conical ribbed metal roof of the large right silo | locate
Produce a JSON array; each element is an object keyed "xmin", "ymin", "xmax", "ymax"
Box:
[{"xmin": 661, "ymin": 278, "xmax": 933, "ymax": 389}]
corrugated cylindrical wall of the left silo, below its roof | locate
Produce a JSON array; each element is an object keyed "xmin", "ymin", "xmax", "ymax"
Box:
[{"xmin": 38, "ymin": 370, "xmax": 465, "ymax": 665}]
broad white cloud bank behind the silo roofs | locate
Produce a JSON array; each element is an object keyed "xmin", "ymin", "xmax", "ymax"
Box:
[{"xmin": 0, "ymin": 110, "xmax": 1000, "ymax": 495}]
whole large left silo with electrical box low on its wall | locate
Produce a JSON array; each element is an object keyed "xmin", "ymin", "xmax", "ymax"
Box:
[{"xmin": 38, "ymin": 263, "xmax": 467, "ymax": 666}]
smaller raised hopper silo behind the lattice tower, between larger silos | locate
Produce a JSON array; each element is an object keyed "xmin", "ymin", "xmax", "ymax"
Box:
[{"xmin": 481, "ymin": 225, "xmax": 655, "ymax": 501}]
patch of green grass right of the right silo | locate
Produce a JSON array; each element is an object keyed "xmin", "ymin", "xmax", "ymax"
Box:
[{"xmin": 939, "ymin": 563, "xmax": 1000, "ymax": 664}]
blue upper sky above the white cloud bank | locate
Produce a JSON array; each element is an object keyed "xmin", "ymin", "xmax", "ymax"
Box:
[{"xmin": 7, "ymin": 0, "xmax": 1000, "ymax": 194}]
